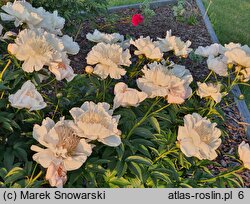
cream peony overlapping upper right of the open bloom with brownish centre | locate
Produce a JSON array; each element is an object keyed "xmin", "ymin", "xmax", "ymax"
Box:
[{"xmin": 70, "ymin": 102, "xmax": 121, "ymax": 147}]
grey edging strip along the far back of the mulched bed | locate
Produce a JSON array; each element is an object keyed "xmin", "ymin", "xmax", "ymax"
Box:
[{"xmin": 108, "ymin": 0, "xmax": 177, "ymax": 12}]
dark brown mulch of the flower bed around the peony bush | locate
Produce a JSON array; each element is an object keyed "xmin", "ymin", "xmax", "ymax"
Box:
[{"xmin": 72, "ymin": 1, "xmax": 250, "ymax": 187}]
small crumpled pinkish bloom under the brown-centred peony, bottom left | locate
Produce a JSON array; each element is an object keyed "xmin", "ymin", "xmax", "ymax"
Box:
[{"xmin": 45, "ymin": 162, "xmax": 67, "ymax": 188}]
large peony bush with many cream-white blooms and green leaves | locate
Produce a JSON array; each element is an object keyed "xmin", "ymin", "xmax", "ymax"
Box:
[{"xmin": 0, "ymin": 1, "xmax": 250, "ymax": 188}]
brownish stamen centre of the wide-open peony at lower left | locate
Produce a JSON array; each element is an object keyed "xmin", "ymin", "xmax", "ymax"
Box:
[{"xmin": 55, "ymin": 125, "xmax": 80, "ymax": 155}]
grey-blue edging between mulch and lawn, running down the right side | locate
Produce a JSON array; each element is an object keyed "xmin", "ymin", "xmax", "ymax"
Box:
[{"xmin": 196, "ymin": 0, "xmax": 250, "ymax": 140}]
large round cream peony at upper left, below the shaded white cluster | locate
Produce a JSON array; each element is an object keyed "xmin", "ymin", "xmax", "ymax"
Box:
[{"xmin": 8, "ymin": 29, "xmax": 64, "ymax": 72}]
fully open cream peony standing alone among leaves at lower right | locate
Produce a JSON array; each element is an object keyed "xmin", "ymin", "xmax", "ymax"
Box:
[{"xmin": 177, "ymin": 113, "xmax": 221, "ymax": 160}]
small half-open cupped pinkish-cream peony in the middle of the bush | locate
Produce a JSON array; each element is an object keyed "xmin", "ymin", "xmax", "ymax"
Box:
[{"xmin": 113, "ymin": 82, "xmax": 147, "ymax": 109}]
